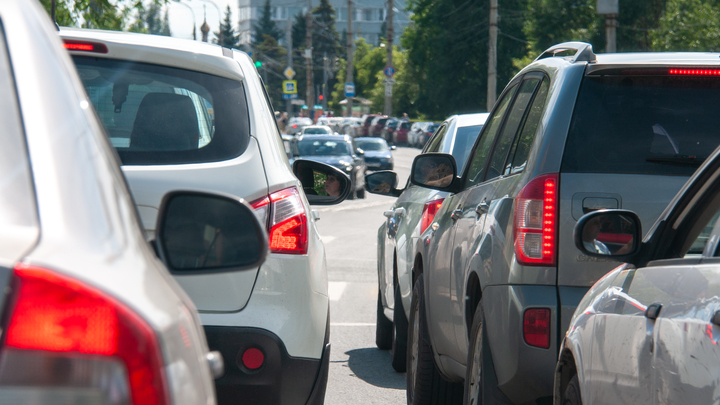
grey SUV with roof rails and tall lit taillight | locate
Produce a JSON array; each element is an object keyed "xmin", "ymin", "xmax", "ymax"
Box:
[{"xmin": 407, "ymin": 42, "xmax": 720, "ymax": 404}]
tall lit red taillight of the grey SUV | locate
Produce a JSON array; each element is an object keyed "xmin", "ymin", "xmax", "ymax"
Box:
[{"xmin": 513, "ymin": 174, "xmax": 559, "ymax": 266}]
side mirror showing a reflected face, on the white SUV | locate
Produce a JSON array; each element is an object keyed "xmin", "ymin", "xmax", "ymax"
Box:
[{"xmin": 293, "ymin": 159, "xmax": 352, "ymax": 205}]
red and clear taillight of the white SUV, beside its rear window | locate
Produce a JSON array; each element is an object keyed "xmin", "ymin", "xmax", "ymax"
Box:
[{"xmin": 250, "ymin": 187, "xmax": 308, "ymax": 255}]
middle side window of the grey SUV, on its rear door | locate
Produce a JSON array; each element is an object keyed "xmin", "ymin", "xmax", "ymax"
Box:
[{"xmin": 485, "ymin": 79, "xmax": 540, "ymax": 180}]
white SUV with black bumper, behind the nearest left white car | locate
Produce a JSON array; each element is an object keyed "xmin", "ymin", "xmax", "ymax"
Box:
[{"xmin": 60, "ymin": 29, "xmax": 349, "ymax": 404}]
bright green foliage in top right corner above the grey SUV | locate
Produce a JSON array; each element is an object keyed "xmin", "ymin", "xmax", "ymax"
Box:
[{"xmin": 650, "ymin": 0, "xmax": 720, "ymax": 52}]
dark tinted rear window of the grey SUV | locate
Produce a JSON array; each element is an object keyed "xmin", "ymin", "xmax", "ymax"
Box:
[{"xmin": 561, "ymin": 73, "xmax": 720, "ymax": 176}]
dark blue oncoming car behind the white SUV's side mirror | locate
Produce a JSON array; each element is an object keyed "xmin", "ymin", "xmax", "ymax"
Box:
[{"xmin": 297, "ymin": 135, "xmax": 367, "ymax": 199}]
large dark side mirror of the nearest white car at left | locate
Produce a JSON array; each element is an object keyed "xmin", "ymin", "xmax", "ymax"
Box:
[{"xmin": 155, "ymin": 191, "xmax": 268, "ymax": 274}]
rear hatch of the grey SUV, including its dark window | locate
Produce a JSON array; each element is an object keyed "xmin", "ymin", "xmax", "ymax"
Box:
[{"xmin": 557, "ymin": 66, "xmax": 720, "ymax": 287}]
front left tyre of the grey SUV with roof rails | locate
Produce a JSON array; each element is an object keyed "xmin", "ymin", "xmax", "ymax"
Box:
[{"xmin": 406, "ymin": 276, "xmax": 463, "ymax": 405}]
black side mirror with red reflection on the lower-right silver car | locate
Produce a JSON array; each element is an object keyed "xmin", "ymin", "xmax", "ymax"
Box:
[{"xmin": 574, "ymin": 210, "xmax": 642, "ymax": 262}]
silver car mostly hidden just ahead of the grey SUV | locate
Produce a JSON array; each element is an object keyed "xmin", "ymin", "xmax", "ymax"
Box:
[{"xmin": 366, "ymin": 114, "xmax": 488, "ymax": 372}]
